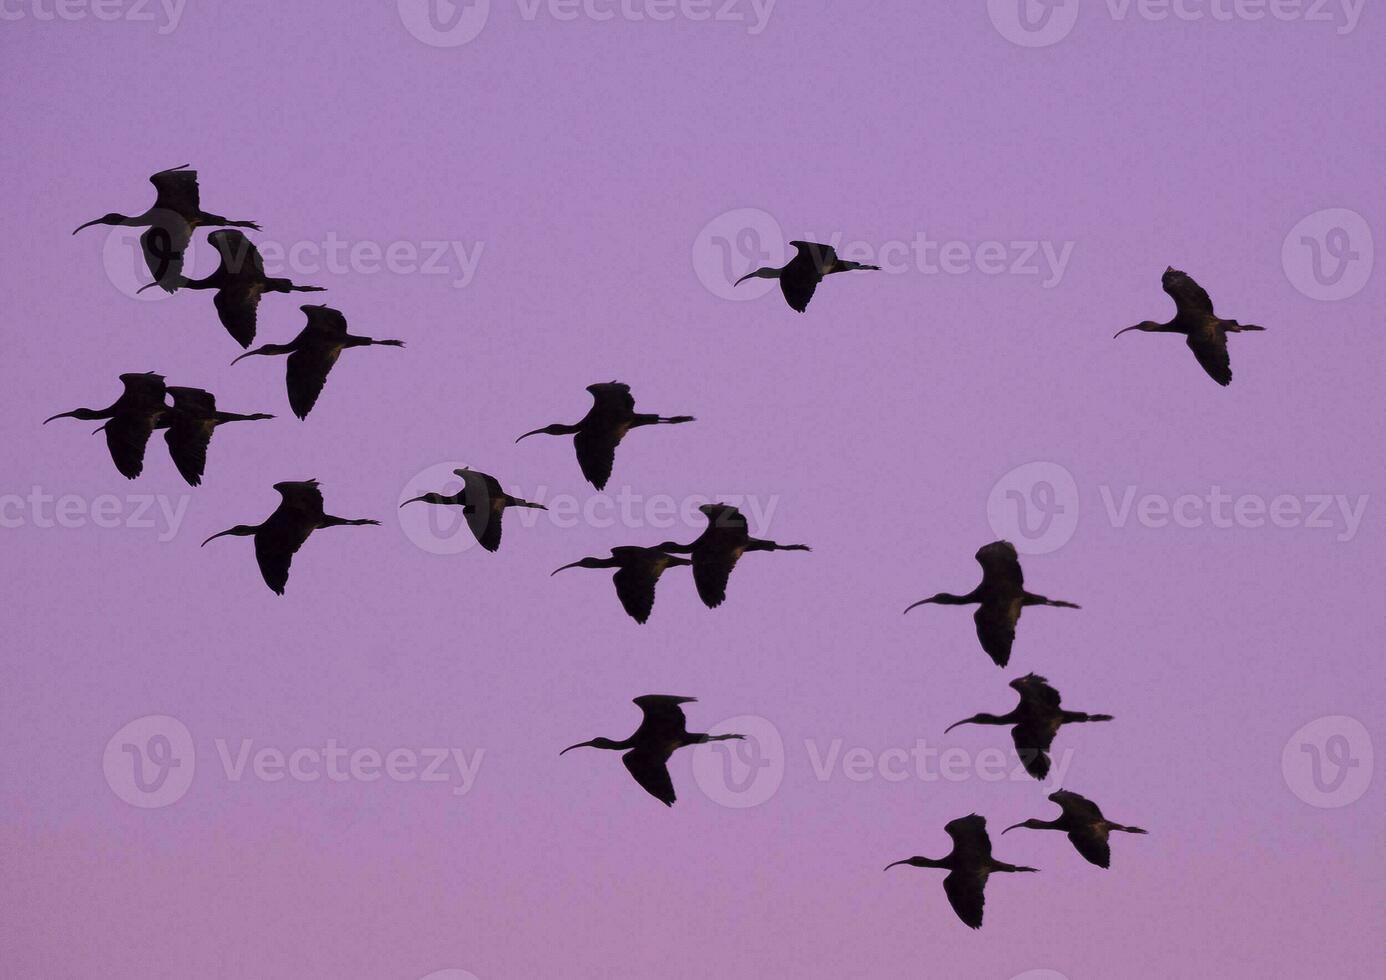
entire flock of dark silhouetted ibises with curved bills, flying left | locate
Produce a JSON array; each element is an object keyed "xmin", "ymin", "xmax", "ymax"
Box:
[{"xmin": 54, "ymin": 165, "xmax": 1263, "ymax": 929}]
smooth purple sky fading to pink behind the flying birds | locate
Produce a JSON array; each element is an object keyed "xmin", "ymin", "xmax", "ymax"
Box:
[{"xmin": 0, "ymin": 0, "xmax": 1386, "ymax": 980}]
